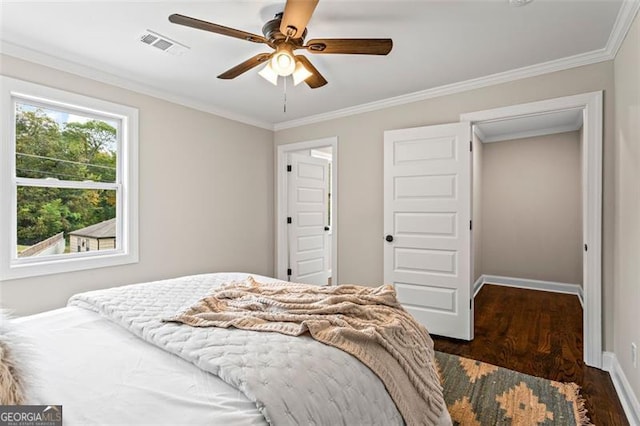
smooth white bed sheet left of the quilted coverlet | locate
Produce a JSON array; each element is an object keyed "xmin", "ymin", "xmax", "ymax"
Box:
[{"xmin": 16, "ymin": 307, "xmax": 267, "ymax": 425}]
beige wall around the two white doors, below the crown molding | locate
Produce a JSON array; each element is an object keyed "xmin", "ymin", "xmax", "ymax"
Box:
[{"xmin": 275, "ymin": 61, "xmax": 614, "ymax": 349}]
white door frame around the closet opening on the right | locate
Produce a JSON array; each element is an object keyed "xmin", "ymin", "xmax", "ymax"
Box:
[{"xmin": 460, "ymin": 91, "xmax": 603, "ymax": 369}]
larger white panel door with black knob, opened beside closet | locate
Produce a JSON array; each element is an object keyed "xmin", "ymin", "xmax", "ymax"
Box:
[{"xmin": 384, "ymin": 123, "xmax": 473, "ymax": 340}]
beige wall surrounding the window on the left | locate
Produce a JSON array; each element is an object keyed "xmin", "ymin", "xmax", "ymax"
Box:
[{"xmin": 0, "ymin": 56, "xmax": 274, "ymax": 314}]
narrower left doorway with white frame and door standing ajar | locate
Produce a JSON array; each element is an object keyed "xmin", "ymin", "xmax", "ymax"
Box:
[{"xmin": 276, "ymin": 138, "xmax": 338, "ymax": 285}]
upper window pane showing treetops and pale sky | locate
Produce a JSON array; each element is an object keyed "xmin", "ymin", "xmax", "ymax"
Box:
[{"xmin": 16, "ymin": 102, "xmax": 118, "ymax": 182}]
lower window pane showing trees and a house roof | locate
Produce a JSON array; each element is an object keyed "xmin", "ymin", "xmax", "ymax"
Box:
[{"xmin": 17, "ymin": 186, "xmax": 116, "ymax": 257}]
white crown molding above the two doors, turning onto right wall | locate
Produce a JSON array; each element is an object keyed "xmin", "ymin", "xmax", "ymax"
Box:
[{"xmin": 273, "ymin": 0, "xmax": 640, "ymax": 131}]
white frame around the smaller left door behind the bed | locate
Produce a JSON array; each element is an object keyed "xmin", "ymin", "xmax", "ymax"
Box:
[{"xmin": 275, "ymin": 136, "xmax": 340, "ymax": 285}]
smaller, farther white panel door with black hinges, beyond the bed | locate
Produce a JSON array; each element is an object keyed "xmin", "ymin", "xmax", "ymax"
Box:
[{"xmin": 287, "ymin": 154, "xmax": 330, "ymax": 285}]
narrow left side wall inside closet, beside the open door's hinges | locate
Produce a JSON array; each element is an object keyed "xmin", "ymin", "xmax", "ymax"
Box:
[{"xmin": 471, "ymin": 133, "xmax": 484, "ymax": 282}]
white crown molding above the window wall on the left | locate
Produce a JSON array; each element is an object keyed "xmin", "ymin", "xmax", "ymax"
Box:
[{"xmin": 0, "ymin": 40, "xmax": 273, "ymax": 130}]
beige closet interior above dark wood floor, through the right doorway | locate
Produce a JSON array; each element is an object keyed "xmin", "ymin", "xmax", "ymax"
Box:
[{"xmin": 472, "ymin": 109, "xmax": 585, "ymax": 296}]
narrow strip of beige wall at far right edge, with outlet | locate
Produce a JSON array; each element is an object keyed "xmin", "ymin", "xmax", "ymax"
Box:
[{"xmin": 613, "ymin": 9, "xmax": 640, "ymax": 397}]
